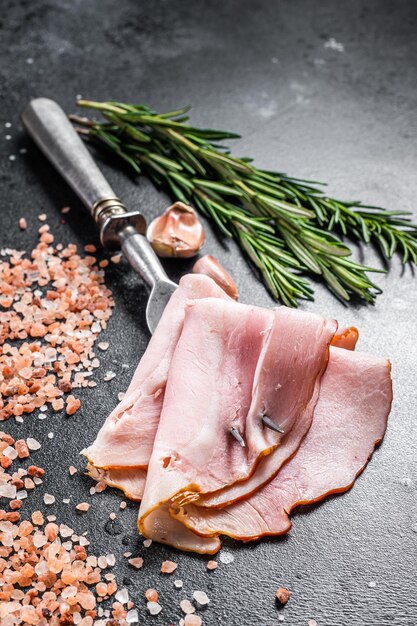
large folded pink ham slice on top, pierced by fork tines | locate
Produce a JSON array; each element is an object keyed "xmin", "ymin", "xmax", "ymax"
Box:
[{"xmin": 138, "ymin": 299, "xmax": 337, "ymax": 543}]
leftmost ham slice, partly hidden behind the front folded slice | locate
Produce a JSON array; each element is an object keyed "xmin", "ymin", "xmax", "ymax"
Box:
[{"xmin": 84, "ymin": 274, "xmax": 230, "ymax": 469}]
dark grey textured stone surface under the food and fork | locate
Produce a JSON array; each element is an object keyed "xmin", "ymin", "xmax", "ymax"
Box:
[{"xmin": 0, "ymin": 0, "xmax": 417, "ymax": 626}]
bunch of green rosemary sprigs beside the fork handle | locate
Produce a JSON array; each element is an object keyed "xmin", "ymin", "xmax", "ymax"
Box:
[{"xmin": 72, "ymin": 100, "xmax": 417, "ymax": 306}]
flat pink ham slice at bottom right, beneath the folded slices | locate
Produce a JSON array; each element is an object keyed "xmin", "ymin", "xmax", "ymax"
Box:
[{"xmin": 175, "ymin": 347, "xmax": 392, "ymax": 540}]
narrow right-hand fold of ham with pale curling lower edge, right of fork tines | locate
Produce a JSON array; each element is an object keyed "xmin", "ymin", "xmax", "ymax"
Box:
[{"xmin": 198, "ymin": 307, "xmax": 337, "ymax": 508}]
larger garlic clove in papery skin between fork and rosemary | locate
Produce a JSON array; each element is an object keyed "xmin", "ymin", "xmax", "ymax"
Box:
[{"xmin": 146, "ymin": 202, "xmax": 204, "ymax": 259}]
